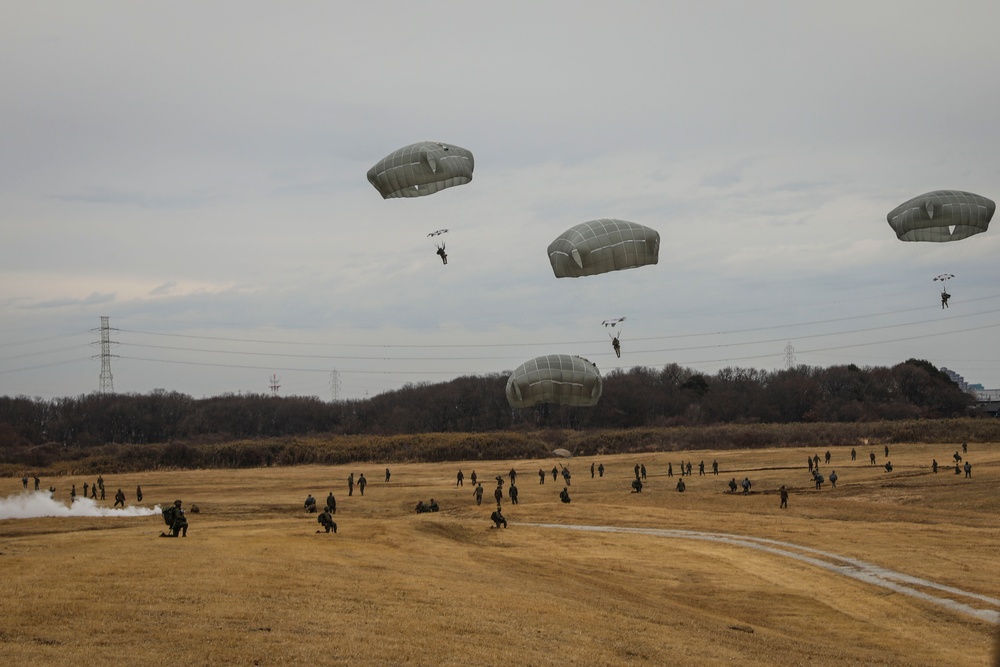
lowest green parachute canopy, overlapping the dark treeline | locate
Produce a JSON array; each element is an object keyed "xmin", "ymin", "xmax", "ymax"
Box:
[{"xmin": 506, "ymin": 354, "xmax": 602, "ymax": 408}]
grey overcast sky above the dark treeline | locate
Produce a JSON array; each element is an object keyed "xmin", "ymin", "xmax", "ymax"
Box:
[{"xmin": 0, "ymin": 0, "xmax": 1000, "ymax": 400}]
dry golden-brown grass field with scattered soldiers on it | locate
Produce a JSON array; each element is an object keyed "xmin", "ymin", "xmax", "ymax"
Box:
[{"xmin": 0, "ymin": 443, "xmax": 1000, "ymax": 666}]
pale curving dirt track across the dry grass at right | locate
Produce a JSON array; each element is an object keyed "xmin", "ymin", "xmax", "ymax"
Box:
[{"xmin": 518, "ymin": 523, "xmax": 1000, "ymax": 623}]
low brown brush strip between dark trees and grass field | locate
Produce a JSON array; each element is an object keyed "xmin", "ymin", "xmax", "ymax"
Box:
[{"xmin": 0, "ymin": 418, "xmax": 1000, "ymax": 477}]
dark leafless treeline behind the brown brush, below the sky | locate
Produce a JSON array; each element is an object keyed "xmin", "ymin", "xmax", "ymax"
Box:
[{"xmin": 0, "ymin": 359, "xmax": 974, "ymax": 450}]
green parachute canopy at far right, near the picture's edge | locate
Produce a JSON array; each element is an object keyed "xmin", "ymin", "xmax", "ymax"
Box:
[{"xmin": 886, "ymin": 190, "xmax": 997, "ymax": 243}]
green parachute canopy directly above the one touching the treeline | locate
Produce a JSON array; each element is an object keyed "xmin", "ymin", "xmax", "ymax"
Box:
[{"xmin": 548, "ymin": 218, "xmax": 660, "ymax": 278}]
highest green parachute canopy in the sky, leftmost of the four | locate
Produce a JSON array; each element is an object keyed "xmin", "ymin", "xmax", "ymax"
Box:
[{"xmin": 368, "ymin": 141, "xmax": 475, "ymax": 199}]
